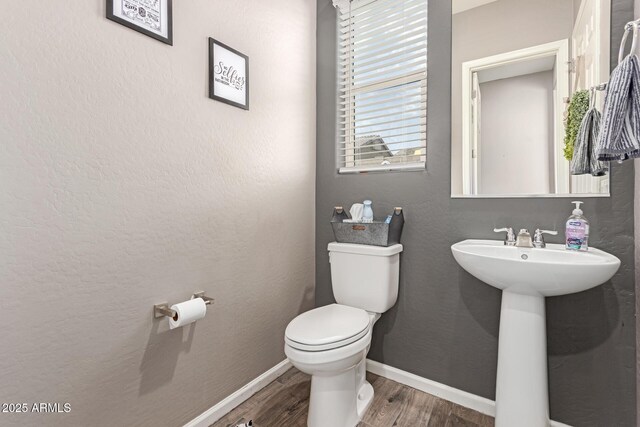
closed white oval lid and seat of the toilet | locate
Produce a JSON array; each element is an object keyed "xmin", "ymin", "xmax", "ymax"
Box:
[{"xmin": 285, "ymin": 304, "xmax": 369, "ymax": 351}]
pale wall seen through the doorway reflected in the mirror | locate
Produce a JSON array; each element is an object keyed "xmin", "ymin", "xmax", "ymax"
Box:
[{"xmin": 478, "ymin": 71, "xmax": 553, "ymax": 194}]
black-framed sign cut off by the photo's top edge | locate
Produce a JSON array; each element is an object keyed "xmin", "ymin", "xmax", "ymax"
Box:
[{"xmin": 107, "ymin": 0, "xmax": 173, "ymax": 45}]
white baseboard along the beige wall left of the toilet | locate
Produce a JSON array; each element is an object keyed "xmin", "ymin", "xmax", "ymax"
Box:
[{"xmin": 184, "ymin": 359, "xmax": 292, "ymax": 427}]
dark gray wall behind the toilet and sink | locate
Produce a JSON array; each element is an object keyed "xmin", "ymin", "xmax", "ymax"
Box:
[{"xmin": 316, "ymin": 0, "xmax": 636, "ymax": 426}]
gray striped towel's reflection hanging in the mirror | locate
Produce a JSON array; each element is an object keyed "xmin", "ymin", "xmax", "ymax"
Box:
[{"xmin": 571, "ymin": 108, "xmax": 609, "ymax": 176}]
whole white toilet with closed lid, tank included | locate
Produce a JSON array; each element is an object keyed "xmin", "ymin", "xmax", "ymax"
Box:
[{"xmin": 284, "ymin": 242, "xmax": 402, "ymax": 427}]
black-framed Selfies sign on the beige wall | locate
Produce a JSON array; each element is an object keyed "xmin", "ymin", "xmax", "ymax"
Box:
[{"xmin": 209, "ymin": 37, "xmax": 249, "ymax": 110}]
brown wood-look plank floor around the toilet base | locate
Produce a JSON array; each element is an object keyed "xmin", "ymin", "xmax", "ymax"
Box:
[{"xmin": 210, "ymin": 368, "xmax": 494, "ymax": 427}]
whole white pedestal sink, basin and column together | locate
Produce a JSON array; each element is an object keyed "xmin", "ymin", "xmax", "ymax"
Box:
[{"xmin": 451, "ymin": 240, "xmax": 620, "ymax": 427}]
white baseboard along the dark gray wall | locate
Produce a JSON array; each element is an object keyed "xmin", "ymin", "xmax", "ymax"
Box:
[{"xmin": 367, "ymin": 359, "xmax": 570, "ymax": 427}]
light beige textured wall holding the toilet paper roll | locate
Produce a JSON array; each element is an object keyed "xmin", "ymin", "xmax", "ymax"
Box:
[{"xmin": 0, "ymin": 0, "xmax": 316, "ymax": 426}]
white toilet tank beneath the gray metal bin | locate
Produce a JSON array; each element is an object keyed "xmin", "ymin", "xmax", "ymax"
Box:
[{"xmin": 328, "ymin": 242, "xmax": 402, "ymax": 313}]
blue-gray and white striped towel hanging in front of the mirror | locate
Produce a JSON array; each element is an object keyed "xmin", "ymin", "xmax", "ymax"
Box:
[{"xmin": 596, "ymin": 55, "xmax": 640, "ymax": 161}]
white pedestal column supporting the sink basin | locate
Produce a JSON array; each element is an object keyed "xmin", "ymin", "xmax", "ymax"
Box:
[{"xmin": 496, "ymin": 290, "xmax": 549, "ymax": 427}]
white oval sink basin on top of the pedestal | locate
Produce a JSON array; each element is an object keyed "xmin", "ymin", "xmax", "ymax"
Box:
[{"xmin": 451, "ymin": 240, "xmax": 620, "ymax": 297}]
